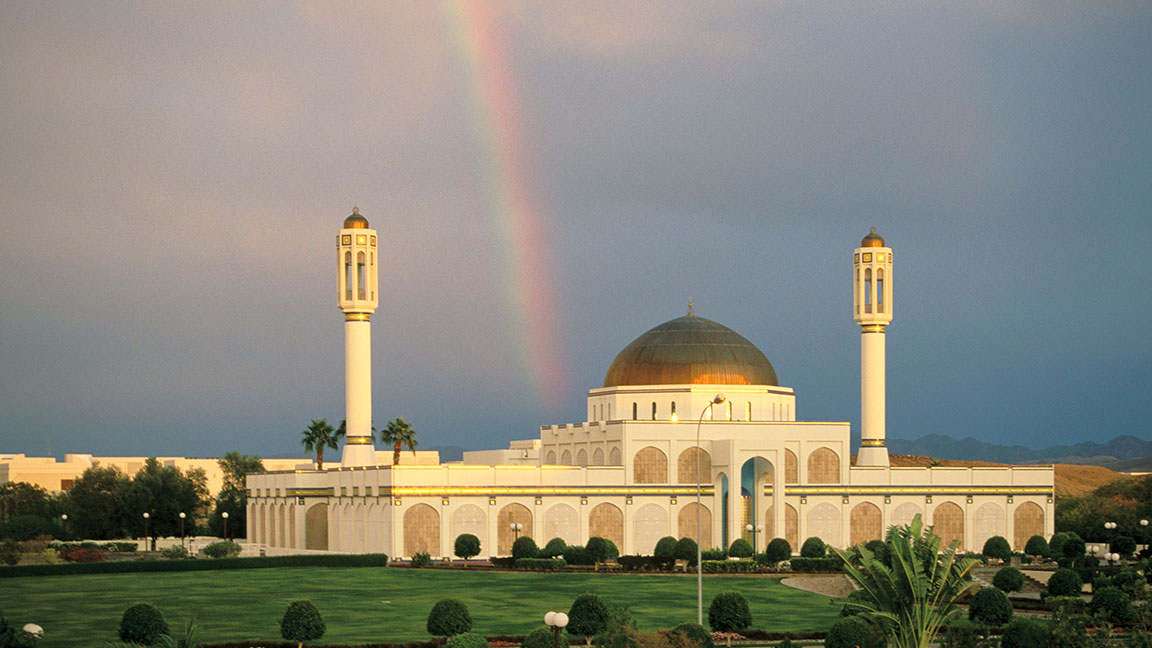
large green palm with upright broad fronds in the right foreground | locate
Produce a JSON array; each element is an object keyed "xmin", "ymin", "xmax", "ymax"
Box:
[{"xmin": 833, "ymin": 515, "xmax": 977, "ymax": 648}]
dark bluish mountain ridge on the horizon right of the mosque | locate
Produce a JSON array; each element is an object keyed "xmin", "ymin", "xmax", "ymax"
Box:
[{"xmin": 888, "ymin": 435, "xmax": 1152, "ymax": 472}]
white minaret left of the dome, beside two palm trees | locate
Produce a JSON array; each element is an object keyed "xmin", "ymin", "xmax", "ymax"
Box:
[{"xmin": 336, "ymin": 209, "xmax": 379, "ymax": 467}]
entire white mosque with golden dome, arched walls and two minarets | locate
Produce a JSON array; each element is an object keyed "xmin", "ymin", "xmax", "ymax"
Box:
[{"xmin": 248, "ymin": 210, "xmax": 1054, "ymax": 558}]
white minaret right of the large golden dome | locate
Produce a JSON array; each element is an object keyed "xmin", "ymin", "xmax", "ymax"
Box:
[{"xmin": 852, "ymin": 229, "xmax": 892, "ymax": 467}]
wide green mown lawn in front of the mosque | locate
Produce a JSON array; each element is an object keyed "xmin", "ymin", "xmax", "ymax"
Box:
[{"xmin": 0, "ymin": 567, "xmax": 839, "ymax": 648}]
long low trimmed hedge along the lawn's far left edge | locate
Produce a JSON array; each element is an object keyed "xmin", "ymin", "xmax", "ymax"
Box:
[{"xmin": 0, "ymin": 553, "xmax": 388, "ymax": 578}]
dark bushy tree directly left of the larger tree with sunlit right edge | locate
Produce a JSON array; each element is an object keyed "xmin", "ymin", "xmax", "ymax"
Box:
[{"xmin": 67, "ymin": 466, "xmax": 131, "ymax": 540}]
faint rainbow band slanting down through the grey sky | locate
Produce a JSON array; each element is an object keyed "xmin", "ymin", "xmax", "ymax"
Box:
[{"xmin": 447, "ymin": 0, "xmax": 568, "ymax": 407}]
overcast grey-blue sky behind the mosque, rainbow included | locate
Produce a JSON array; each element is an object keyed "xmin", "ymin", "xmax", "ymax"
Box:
[{"xmin": 0, "ymin": 0, "xmax": 1152, "ymax": 457}]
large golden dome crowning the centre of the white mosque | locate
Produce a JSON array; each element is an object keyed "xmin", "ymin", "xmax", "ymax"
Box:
[{"xmin": 604, "ymin": 315, "xmax": 778, "ymax": 387}]
